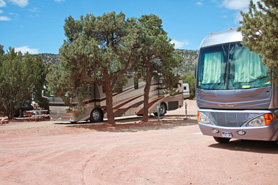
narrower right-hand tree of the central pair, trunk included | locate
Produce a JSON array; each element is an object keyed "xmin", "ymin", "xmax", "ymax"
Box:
[{"xmin": 138, "ymin": 14, "xmax": 182, "ymax": 122}]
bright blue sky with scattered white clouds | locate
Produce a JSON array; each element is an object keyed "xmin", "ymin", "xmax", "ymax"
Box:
[{"xmin": 0, "ymin": 0, "xmax": 258, "ymax": 54}]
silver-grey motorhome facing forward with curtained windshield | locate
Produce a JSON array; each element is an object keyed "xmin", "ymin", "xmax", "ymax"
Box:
[{"xmin": 196, "ymin": 30, "xmax": 278, "ymax": 143}]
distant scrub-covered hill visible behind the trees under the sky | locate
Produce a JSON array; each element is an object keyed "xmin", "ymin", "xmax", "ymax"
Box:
[{"xmin": 39, "ymin": 50, "xmax": 199, "ymax": 75}]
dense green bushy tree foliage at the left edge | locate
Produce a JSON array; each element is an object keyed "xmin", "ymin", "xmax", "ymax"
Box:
[{"xmin": 0, "ymin": 48, "xmax": 45, "ymax": 119}]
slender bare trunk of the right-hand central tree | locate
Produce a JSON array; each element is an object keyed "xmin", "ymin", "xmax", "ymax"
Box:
[{"xmin": 142, "ymin": 62, "xmax": 152, "ymax": 122}]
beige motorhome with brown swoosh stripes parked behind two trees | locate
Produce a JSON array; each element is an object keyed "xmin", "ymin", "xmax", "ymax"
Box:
[{"xmin": 48, "ymin": 77, "xmax": 183, "ymax": 122}]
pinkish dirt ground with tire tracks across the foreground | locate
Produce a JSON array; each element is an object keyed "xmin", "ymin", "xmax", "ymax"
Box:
[{"xmin": 0, "ymin": 101, "xmax": 278, "ymax": 185}]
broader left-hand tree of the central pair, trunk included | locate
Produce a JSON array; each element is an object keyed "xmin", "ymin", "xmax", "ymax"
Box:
[{"xmin": 48, "ymin": 12, "xmax": 139, "ymax": 125}]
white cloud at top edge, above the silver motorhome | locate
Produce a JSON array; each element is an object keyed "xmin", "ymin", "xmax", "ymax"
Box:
[{"xmin": 221, "ymin": 0, "xmax": 260, "ymax": 10}]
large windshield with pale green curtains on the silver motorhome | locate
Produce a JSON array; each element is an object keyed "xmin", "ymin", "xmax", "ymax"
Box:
[{"xmin": 197, "ymin": 43, "xmax": 270, "ymax": 90}]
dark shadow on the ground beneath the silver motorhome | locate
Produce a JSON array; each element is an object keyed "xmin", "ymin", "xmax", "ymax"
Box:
[{"xmin": 209, "ymin": 140, "xmax": 278, "ymax": 154}]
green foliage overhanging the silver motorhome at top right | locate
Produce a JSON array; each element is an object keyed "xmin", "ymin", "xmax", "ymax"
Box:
[{"xmin": 238, "ymin": 0, "xmax": 278, "ymax": 84}]
